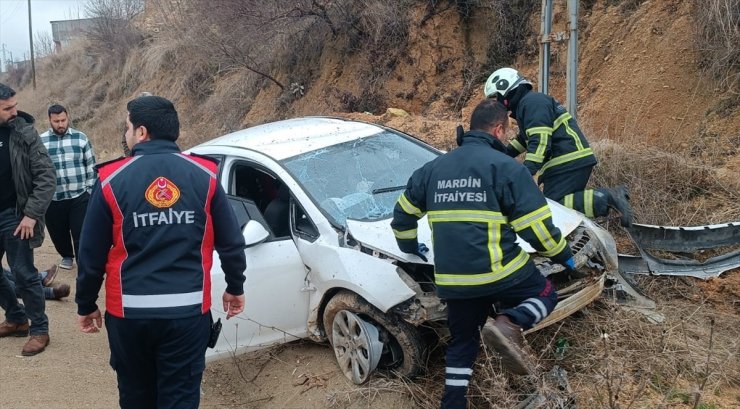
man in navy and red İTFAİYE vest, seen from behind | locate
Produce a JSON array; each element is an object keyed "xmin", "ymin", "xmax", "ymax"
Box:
[{"xmin": 75, "ymin": 96, "xmax": 246, "ymax": 409}]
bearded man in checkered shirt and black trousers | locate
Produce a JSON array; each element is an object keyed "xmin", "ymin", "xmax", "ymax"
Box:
[{"xmin": 41, "ymin": 105, "xmax": 96, "ymax": 270}]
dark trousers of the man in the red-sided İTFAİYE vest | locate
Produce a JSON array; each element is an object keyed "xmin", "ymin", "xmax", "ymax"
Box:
[{"xmin": 105, "ymin": 312, "xmax": 211, "ymax": 409}]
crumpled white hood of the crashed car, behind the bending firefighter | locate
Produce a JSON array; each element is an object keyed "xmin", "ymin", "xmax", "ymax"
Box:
[{"xmin": 347, "ymin": 199, "xmax": 585, "ymax": 264}]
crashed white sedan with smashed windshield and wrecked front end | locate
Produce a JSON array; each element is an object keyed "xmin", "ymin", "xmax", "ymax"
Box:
[{"xmin": 191, "ymin": 117, "xmax": 640, "ymax": 384}]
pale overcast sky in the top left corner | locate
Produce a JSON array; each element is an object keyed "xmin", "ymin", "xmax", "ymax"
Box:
[{"xmin": 0, "ymin": 0, "xmax": 86, "ymax": 69}]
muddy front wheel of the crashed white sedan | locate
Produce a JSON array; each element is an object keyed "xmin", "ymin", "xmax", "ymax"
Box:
[{"xmin": 323, "ymin": 291, "xmax": 426, "ymax": 383}]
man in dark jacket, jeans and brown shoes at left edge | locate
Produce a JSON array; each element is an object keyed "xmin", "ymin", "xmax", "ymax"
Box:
[{"xmin": 0, "ymin": 84, "xmax": 56, "ymax": 356}]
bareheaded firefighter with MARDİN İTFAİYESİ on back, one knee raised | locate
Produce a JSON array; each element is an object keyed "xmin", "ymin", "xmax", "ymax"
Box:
[{"xmin": 391, "ymin": 99, "xmax": 573, "ymax": 408}]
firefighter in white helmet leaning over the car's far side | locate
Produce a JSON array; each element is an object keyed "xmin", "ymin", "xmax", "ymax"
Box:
[{"xmin": 484, "ymin": 68, "xmax": 632, "ymax": 227}]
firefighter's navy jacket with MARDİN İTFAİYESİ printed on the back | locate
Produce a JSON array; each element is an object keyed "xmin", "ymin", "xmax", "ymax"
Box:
[{"xmin": 391, "ymin": 131, "xmax": 571, "ymax": 298}]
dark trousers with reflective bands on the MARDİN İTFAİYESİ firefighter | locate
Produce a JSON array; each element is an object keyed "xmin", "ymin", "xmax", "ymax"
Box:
[{"xmin": 440, "ymin": 270, "xmax": 557, "ymax": 409}]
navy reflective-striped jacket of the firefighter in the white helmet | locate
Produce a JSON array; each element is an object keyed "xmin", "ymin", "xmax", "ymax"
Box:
[{"xmin": 507, "ymin": 91, "xmax": 596, "ymax": 175}]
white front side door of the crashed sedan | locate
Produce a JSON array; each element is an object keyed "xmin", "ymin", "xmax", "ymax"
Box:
[{"xmin": 209, "ymin": 159, "xmax": 309, "ymax": 355}]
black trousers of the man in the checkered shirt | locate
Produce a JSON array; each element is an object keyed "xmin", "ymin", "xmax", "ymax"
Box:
[{"xmin": 46, "ymin": 193, "xmax": 90, "ymax": 258}]
